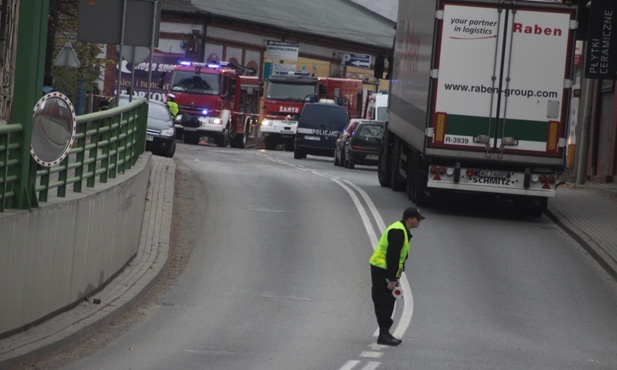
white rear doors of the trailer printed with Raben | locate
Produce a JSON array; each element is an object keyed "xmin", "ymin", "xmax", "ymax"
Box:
[{"xmin": 427, "ymin": 1, "xmax": 575, "ymax": 157}]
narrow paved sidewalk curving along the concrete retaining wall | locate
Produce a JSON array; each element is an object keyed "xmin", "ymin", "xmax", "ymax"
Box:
[{"xmin": 0, "ymin": 156, "xmax": 176, "ymax": 369}]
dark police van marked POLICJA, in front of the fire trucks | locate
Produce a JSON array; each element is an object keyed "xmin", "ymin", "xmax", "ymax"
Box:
[{"xmin": 294, "ymin": 103, "xmax": 349, "ymax": 159}]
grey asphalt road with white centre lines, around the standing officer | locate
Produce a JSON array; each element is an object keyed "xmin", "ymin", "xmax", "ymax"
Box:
[{"xmin": 30, "ymin": 144, "xmax": 617, "ymax": 370}]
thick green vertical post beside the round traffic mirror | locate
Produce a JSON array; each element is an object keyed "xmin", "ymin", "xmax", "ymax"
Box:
[{"xmin": 11, "ymin": 0, "xmax": 49, "ymax": 209}]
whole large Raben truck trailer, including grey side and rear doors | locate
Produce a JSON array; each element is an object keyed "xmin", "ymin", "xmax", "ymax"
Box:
[{"xmin": 378, "ymin": 0, "xmax": 577, "ymax": 213}]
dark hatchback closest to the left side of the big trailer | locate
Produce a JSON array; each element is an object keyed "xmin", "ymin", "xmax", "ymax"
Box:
[{"xmin": 343, "ymin": 121, "xmax": 385, "ymax": 169}]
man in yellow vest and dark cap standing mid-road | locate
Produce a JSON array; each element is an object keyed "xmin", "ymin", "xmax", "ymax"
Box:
[{"xmin": 369, "ymin": 207, "xmax": 424, "ymax": 346}]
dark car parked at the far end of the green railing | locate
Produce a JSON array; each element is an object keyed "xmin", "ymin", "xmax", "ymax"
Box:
[{"xmin": 114, "ymin": 95, "xmax": 176, "ymax": 158}]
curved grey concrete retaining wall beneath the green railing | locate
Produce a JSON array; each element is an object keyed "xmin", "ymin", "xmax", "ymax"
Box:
[{"xmin": 0, "ymin": 152, "xmax": 152, "ymax": 336}]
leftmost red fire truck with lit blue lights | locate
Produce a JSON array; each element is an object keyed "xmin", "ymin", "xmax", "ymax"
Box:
[{"xmin": 167, "ymin": 62, "xmax": 260, "ymax": 148}]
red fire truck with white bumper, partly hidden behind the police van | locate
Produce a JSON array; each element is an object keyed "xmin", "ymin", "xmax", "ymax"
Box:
[{"xmin": 260, "ymin": 72, "xmax": 363, "ymax": 151}]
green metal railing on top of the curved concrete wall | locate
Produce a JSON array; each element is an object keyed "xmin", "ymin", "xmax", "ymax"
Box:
[{"xmin": 0, "ymin": 99, "xmax": 148, "ymax": 212}]
